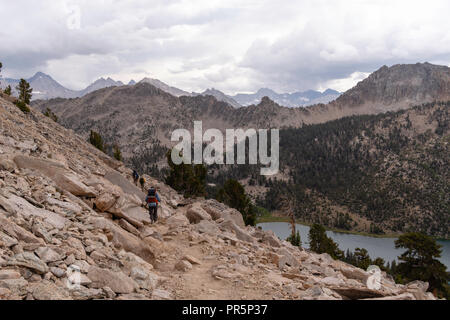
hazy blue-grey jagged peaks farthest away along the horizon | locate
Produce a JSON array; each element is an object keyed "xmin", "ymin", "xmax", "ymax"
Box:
[{"xmin": 0, "ymin": 72, "xmax": 341, "ymax": 108}]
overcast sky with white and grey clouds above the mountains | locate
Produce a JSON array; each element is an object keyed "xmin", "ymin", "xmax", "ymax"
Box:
[{"xmin": 0, "ymin": 0, "xmax": 450, "ymax": 94}]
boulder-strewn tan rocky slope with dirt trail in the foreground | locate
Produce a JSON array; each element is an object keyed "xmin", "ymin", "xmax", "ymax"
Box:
[{"xmin": 0, "ymin": 98, "xmax": 434, "ymax": 300}]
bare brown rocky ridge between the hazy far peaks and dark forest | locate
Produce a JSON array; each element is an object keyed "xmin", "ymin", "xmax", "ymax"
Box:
[{"xmin": 34, "ymin": 63, "xmax": 450, "ymax": 152}]
